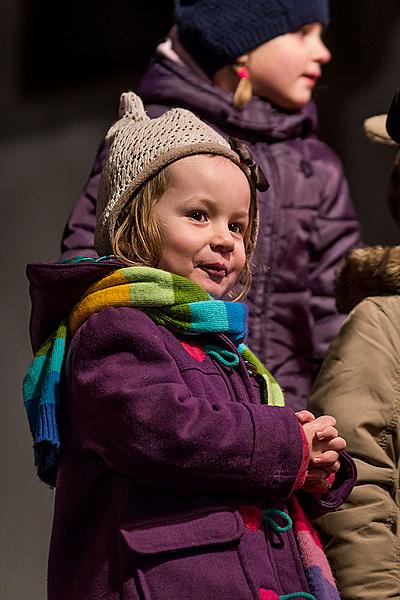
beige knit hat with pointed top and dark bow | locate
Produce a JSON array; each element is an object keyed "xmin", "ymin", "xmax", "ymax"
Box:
[{"xmin": 95, "ymin": 92, "xmax": 268, "ymax": 256}]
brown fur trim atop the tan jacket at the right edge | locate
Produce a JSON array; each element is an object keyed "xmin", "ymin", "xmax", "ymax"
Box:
[{"xmin": 336, "ymin": 246, "xmax": 400, "ymax": 313}]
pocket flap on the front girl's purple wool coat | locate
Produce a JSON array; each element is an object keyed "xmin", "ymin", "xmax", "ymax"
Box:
[{"xmin": 121, "ymin": 511, "xmax": 243, "ymax": 554}]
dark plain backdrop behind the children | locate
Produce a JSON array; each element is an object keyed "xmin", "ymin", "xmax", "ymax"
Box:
[{"xmin": 0, "ymin": 0, "xmax": 400, "ymax": 600}]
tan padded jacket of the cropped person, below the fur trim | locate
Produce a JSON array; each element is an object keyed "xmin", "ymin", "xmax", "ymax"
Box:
[{"xmin": 310, "ymin": 297, "xmax": 400, "ymax": 600}]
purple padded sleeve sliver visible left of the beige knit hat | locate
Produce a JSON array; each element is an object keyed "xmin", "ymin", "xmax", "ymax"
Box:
[{"xmin": 60, "ymin": 140, "xmax": 106, "ymax": 260}]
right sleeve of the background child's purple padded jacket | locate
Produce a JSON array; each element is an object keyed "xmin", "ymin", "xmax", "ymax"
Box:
[{"xmin": 309, "ymin": 145, "xmax": 361, "ymax": 373}]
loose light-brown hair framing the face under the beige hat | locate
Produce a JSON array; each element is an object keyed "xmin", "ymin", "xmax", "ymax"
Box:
[{"xmin": 113, "ymin": 154, "xmax": 257, "ymax": 301}]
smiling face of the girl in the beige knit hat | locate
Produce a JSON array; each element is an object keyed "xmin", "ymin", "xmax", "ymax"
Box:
[{"xmin": 154, "ymin": 155, "xmax": 251, "ymax": 298}]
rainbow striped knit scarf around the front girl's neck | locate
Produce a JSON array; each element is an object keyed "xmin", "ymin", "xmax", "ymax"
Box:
[{"xmin": 23, "ymin": 267, "xmax": 284, "ymax": 485}]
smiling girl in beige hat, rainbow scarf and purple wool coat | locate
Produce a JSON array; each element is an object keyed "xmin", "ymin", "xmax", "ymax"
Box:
[{"xmin": 25, "ymin": 93, "xmax": 355, "ymax": 600}]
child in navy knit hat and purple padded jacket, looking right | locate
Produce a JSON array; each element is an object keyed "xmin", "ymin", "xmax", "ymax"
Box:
[{"xmin": 62, "ymin": 0, "xmax": 360, "ymax": 409}]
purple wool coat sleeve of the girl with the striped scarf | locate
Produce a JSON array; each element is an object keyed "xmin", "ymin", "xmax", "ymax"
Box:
[{"xmin": 71, "ymin": 308, "xmax": 302, "ymax": 498}]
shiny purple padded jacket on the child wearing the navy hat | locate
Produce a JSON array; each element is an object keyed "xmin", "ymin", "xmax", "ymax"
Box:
[{"xmin": 62, "ymin": 56, "xmax": 361, "ymax": 409}]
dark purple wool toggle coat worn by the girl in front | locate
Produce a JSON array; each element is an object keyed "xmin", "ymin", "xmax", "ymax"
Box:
[{"xmin": 28, "ymin": 263, "xmax": 355, "ymax": 600}]
